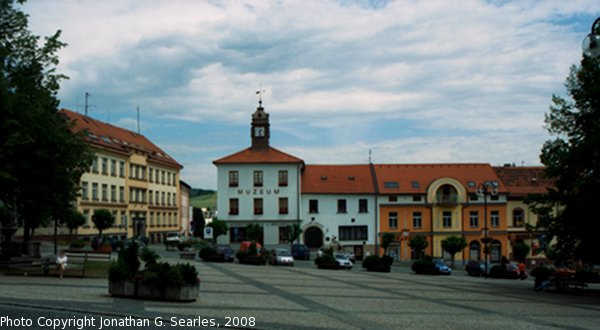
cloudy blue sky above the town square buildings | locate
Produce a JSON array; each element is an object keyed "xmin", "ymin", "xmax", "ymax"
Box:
[{"xmin": 23, "ymin": 0, "xmax": 600, "ymax": 189}]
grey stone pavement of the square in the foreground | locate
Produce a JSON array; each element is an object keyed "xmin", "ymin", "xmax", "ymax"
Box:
[{"xmin": 0, "ymin": 260, "xmax": 600, "ymax": 329}]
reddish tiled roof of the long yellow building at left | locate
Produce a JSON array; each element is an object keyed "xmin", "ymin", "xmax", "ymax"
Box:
[{"xmin": 59, "ymin": 109, "xmax": 183, "ymax": 168}]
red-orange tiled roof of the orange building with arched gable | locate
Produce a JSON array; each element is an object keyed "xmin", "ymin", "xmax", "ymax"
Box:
[{"xmin": 374, "ymin": 164, "xmax": 506, "ymax": 194}]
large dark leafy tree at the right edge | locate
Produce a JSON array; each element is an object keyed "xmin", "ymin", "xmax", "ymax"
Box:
[{"xmin": 529, "ymin": 53, "xmax": 600, "ymax": 264}]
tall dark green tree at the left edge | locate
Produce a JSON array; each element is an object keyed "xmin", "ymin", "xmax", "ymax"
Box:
[{"xmin": 0, "ymin": 0, "xmax": 91, "ymax": 241}]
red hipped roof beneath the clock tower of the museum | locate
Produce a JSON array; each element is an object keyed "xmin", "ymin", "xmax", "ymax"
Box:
[{"xmin": 213, "ymin": 147, "xmax": 304, "ymax": 165}]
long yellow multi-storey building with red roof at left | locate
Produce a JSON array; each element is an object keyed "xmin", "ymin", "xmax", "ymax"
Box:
[{"xmin": 61, "ymin": 109, "xmax": 182, "ymax": 242}]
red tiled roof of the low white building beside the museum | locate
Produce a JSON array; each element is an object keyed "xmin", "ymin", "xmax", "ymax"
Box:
[{"xmin": 302, "ymin": 164, "xmax": 375, "ymax": 194}]
